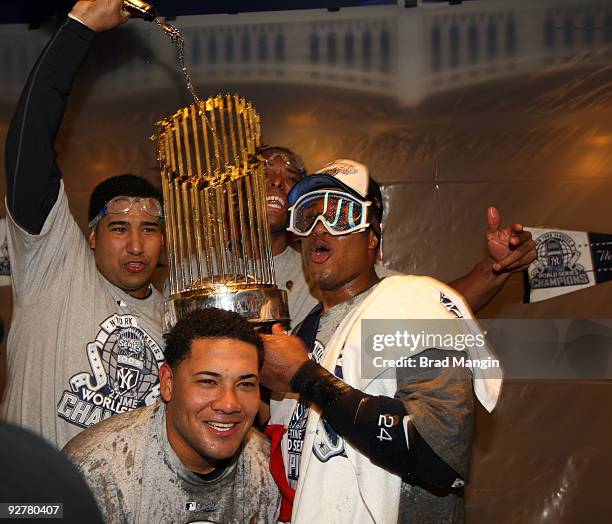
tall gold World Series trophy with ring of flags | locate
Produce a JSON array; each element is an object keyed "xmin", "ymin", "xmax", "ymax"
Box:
[{"xmin": 152, "ymin": 95, "xmax": 289, "ymax": 328}]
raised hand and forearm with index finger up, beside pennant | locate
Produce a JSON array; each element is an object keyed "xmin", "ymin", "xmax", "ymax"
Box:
[{"xmin": 448, "ymin": 207, "xmax": 537, "ymax": 312}]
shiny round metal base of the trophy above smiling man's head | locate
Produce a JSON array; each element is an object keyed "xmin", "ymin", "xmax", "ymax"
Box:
[{"xmin": 164, "ymin": 286, "xmax": 290, "ymax": 332}]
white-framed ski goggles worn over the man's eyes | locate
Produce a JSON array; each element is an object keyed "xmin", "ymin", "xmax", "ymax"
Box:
[{"xmin": 287, "ymin": 189, "xmax": 371, "ymax": 237}]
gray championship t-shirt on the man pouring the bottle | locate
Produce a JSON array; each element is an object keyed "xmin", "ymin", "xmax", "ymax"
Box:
[{"xmin": 0, "ymin": 183, "xmax": 163, "ymax": 448}]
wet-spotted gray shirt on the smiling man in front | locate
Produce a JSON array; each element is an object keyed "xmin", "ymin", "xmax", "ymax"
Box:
[{"xmin": 64, "ymin": 402, "xmax": 280, "ymax": 524}]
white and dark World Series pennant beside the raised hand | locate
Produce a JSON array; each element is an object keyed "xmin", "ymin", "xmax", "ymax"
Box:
[{"xmin": 525, "ymin": 227, "xmax": 612, "ymax": 302}]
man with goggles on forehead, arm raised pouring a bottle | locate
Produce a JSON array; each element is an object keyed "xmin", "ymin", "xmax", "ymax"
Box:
[{"xmin": 0, "ymin": 0, "xmax": 164, "ymax": 448}]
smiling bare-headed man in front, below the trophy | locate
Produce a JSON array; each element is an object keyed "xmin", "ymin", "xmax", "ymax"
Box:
[{"xmin": 64, "ymin": 308, "xmax": 279, "ymax": 523}]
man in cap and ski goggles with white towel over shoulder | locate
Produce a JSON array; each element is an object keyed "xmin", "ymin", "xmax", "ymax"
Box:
[{"xmin": 261, "ymin": 160, "xmax": 499, "ymax": 524}]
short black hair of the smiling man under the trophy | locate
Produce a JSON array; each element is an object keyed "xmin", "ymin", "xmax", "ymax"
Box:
[{"xmin": 164, "ymin": 307, "xmax": 264, "ymax": 369}]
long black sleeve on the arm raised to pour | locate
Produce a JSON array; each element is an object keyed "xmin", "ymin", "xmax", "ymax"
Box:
[{"xmin": 5, "ymin": 18, "xmax": 95, "ymax": 234}]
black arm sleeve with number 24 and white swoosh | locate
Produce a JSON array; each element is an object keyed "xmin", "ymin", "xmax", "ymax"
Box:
[{"xmin": 291, "ymin": 361, "xmax": 464, "ymax": 490}]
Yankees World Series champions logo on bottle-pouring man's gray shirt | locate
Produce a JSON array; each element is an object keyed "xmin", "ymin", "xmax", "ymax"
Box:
[{"xmin": 57, "ymin": 315, "xmax": 164, "ymax": 428}]
